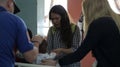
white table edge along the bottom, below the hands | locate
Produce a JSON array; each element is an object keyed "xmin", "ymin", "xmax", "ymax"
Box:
[{"xmin": 15, "ymin": 62, "xmax": 55, "ymax": 67}]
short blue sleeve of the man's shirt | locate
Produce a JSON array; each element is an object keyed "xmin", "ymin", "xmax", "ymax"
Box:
[{"xmin": 16, "ymin": 19, "xmax": 33, "ymax": 53}]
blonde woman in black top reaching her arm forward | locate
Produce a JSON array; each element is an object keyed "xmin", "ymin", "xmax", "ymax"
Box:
[{"xmin": 43, "ymin": 0, "xmax": 120, "ymax": 67}]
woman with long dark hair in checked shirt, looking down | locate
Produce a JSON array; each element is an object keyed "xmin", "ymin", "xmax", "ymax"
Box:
[{"xmin": 47, "ymin": 5, "xmax": 80, "ymax": 67}]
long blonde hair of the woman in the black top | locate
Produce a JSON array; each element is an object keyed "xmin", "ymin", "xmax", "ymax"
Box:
[{"xmin": 82, "ymin": 0, "xmax": 120, "ymax": 35}]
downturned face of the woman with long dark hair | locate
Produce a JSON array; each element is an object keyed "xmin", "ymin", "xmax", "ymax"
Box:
[{"xmin": 51, "ymin": 13, "xmax": 61, "ymax": 28}]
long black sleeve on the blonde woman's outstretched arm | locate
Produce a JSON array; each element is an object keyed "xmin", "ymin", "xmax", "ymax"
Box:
[{"xmin": 59, "ymin": 21, "xmax": 103, "ymax": 65}]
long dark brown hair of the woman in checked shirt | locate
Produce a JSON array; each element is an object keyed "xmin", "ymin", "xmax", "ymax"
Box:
[{"xmin": 49, "ymin": 5, "xmax": 72, "ymax": 48}]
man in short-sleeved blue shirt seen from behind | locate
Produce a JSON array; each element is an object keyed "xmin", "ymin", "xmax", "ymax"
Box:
[{"xmin": 0, "ymin": 0, "xmax": 38, "ymax": 67}]
